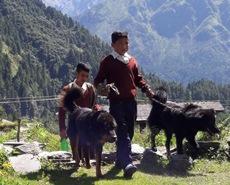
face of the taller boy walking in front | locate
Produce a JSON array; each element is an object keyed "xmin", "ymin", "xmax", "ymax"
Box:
[{"xmin": 111, "ymin": 37, "xmax": 129, "ymax": 55}]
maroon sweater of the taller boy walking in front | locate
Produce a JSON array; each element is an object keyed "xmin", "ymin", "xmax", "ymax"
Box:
[{"xmin": 94, "ymin": 55, "xmax": 148, "ymax": 102}]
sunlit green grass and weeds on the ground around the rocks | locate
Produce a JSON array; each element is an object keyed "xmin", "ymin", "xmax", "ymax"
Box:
[{"xmin": 0, "ymin": 118, "xmax": 230, "ymax": 185}]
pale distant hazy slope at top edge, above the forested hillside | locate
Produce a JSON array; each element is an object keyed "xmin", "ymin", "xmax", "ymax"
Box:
[{"xmin": 42, "ymin": 0, "xmax": 105, "ymax": 17}]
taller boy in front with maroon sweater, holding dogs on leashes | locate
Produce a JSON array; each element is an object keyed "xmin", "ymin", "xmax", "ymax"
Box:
[{"xmin": 94, "ymin": 30, "xmax": 153, "ymax": 178}]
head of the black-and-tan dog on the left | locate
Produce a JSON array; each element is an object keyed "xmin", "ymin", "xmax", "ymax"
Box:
[{"xmin": 97, "ymin": 111, "xmax": 117, "ymax": 144}]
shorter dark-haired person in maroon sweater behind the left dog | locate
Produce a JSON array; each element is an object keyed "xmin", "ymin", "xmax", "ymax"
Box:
[{"xmin": 58, "ymin": 62, "xmax": 100, "ymax": 159}]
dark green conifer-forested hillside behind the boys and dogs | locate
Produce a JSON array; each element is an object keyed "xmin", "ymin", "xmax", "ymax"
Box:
[{"xmin": 0, "ymin": 0, "xmax": 230, "ymax": 118}]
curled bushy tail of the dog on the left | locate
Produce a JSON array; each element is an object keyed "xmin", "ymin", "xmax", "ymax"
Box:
[{"xmin": 59, "ymin": 87, "xmax": 83, "ymax": 113}]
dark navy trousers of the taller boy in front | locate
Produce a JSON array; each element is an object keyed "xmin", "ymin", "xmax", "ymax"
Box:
[{"xmin": 110, "ymin": 100, "xmax": 137, "ymax": 169}]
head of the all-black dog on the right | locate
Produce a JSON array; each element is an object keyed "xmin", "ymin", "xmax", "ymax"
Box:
[{"xmin": 195, "ymin": 109, "xmax": 220, "ymax": 136}]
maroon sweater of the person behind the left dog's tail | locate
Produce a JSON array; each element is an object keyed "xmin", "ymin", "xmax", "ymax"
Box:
[{"xmin": 58, "ymin": 85, "xmax": 100, "ymax": 131}]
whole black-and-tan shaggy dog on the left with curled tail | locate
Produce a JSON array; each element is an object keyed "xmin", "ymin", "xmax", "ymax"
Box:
[{"xmin": 59, "ymin": 88, "xmax": 117, "ymax": 177}]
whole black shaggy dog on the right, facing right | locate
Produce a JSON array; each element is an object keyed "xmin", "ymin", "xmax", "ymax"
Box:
[{"xmin": 148, "ymin": 87, "xmax": 220, "ymax": 158}]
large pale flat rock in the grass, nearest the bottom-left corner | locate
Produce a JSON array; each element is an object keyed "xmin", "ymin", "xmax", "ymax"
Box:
[{"xmin": 9, "ymin": 154, "xmax": 41, "ymax": 174}]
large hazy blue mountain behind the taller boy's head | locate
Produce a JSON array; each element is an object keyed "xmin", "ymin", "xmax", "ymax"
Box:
[{"xmin": 71, "ymin": 0, "xmax": 230, "ymax": 85}]
